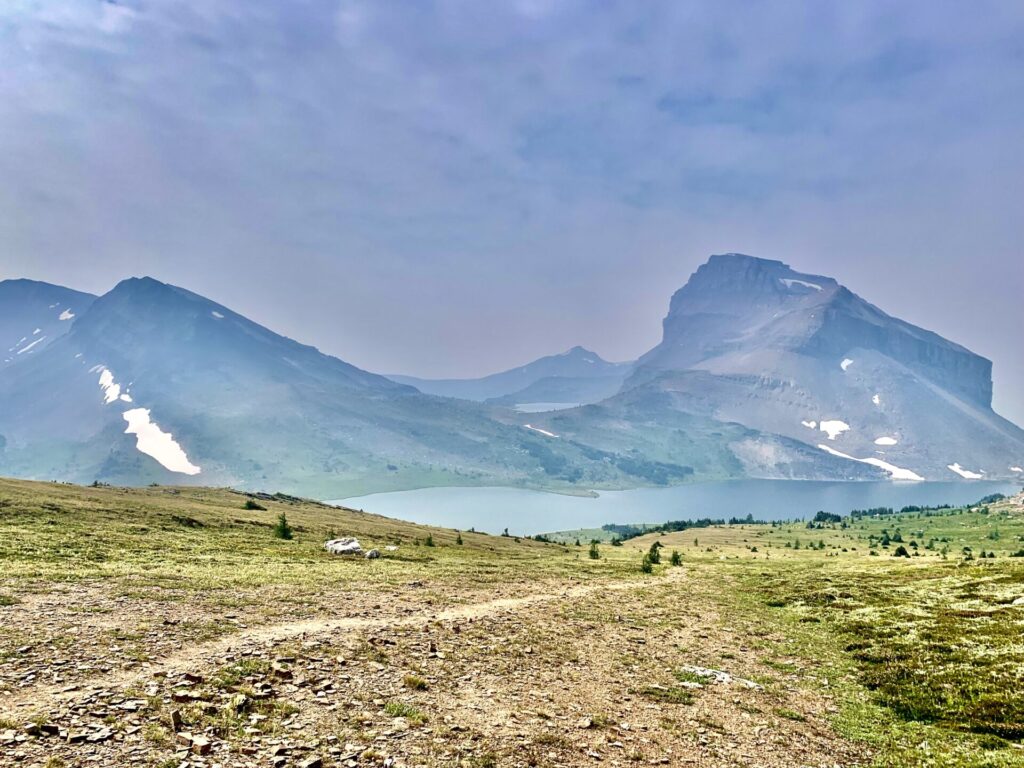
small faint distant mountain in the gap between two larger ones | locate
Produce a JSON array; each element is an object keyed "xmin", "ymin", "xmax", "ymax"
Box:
[{"xmin": 389, "ymin": 346, "xmax": 632, "ymax": 406}]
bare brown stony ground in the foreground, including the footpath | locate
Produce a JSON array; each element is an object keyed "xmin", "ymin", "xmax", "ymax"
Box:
[{"xmin": 0, "ymin": 568, "xmax": 863, "ymax": 768}]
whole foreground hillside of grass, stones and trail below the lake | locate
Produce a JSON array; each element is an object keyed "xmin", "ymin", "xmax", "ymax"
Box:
[{"xmin": 0, "ymin": 480, "xmax": 1024, "ymax": 768}]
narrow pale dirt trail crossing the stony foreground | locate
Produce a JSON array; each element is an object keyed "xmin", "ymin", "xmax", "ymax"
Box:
[{"xmin": 0, "ymin": 568, "xmax": 684, "ymax": 719}]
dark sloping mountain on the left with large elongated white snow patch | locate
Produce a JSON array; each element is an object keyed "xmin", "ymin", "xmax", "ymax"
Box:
[{"xmin": 0, "ymin": 279, "xmax": 682, "ymax": 498}]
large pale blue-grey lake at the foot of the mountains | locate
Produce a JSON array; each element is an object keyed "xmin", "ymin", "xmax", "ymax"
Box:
[{"xmin": 328, "ymin": 480, "xmax": 1021, "ymax": 536}]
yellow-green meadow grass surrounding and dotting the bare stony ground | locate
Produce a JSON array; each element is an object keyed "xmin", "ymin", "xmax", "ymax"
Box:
[{"xmin": 0, "ymin": 480, "xmax": 1024, "ymax": 768}]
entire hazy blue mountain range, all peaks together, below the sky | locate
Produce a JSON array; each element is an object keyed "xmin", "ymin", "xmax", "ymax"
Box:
[{"xmin": 0, "ymin": 254, "xmax": 1024, "ymax": 498}]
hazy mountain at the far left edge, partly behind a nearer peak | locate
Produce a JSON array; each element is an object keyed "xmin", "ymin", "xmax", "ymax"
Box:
[{"xmin": 0, "ymin": 280, "xmax": 96, "ymax": 369}]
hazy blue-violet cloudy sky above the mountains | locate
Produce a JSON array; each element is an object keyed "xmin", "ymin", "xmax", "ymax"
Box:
[{"xmin": 0, "ymin": 0, "xmax": 1024, "ymax": 423}]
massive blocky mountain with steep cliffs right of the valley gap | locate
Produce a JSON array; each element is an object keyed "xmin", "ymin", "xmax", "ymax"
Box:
[{"xmin": 520, "ymin": 254, "xmax": 1024, "ymax": 479}]
